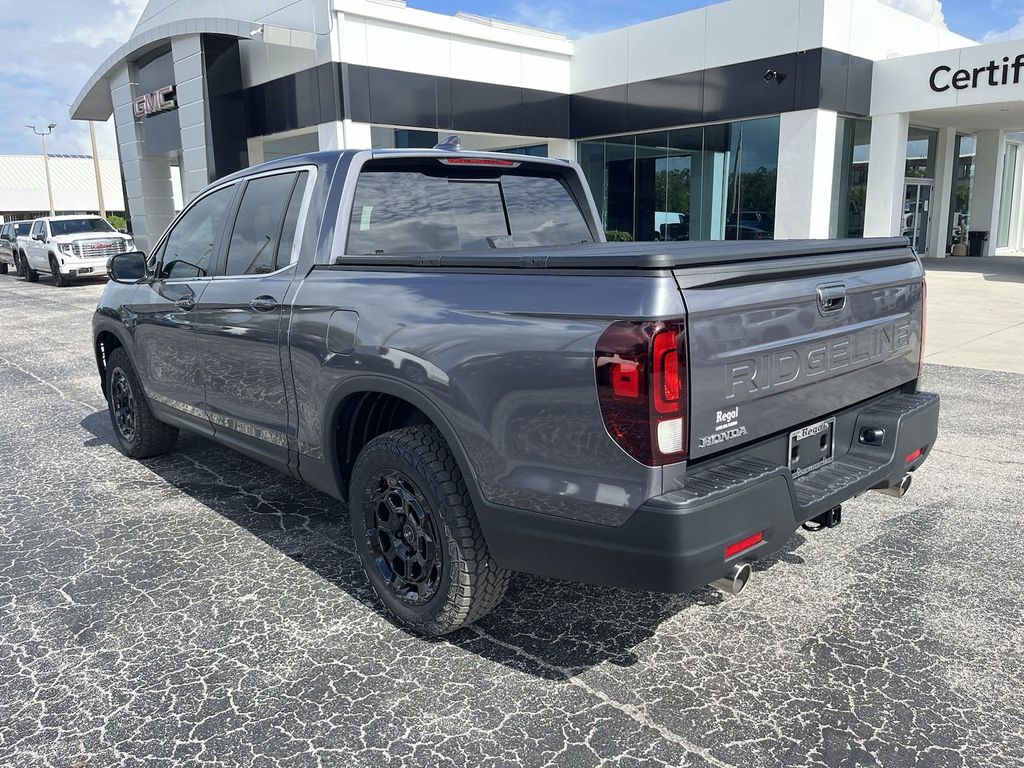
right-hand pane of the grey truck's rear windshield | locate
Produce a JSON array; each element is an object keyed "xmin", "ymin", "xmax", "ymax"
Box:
[{"xmin": 502, "ymin": 175, "xmax": 594, "ymax": 248}]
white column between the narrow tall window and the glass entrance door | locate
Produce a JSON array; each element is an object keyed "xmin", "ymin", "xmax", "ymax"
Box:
[{"xmin": 864, "ymin": 113, "xmax": 910, "ymax": 238}]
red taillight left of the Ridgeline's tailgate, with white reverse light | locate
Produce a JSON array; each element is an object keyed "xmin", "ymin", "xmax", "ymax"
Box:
[{"xmin": 596, "ymin": 321, "xmax": 689, "ymax": 466}]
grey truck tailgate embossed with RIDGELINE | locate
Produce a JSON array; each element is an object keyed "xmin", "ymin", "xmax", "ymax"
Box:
[{"xmin": 674, "ymin": 247, "xmax": 924, "ymax": 459}]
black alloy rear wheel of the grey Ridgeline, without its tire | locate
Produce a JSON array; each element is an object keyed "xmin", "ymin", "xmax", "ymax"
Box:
[{"xmin": 364, "ymin": 469, "xmax": 443, "ymax": 605}]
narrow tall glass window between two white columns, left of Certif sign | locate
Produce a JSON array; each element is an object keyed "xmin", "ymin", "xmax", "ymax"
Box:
[{"xmin": 828, "ymin": 117, "xmax": 871, "ymax": 238}]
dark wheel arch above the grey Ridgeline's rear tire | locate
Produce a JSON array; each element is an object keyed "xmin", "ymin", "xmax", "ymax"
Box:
[{"xmin": 322, "ymin": 376, "xmax": 482, "ymax": 506}]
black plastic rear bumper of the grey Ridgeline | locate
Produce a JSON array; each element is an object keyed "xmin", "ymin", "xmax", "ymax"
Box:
[{"xmin": 480, "ymin": 393, "xmax": 939, "ymax": 592}]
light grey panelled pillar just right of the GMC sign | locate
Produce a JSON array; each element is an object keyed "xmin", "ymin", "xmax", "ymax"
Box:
[{"xmin": 171, "ymin": 35, "xmax": 210, "ymax": 204}]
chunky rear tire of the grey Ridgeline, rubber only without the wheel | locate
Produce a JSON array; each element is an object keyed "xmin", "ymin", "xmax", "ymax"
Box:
[{"xmin": 349, "ymin": 425, "xmax": 511, "ymax": 637}]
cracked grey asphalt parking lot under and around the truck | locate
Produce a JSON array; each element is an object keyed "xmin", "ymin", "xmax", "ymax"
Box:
[{"xmin": 0, "ymin": 275, "xmax": 1024, "ymax": 768}]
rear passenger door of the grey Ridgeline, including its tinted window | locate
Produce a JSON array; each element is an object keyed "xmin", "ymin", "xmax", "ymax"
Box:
[{"xmin": 193, "ymin": 169, "xmax": 312, "ymax": 466}]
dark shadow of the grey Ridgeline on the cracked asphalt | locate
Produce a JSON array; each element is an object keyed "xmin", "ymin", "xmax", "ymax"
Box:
[{"xmin": 81, "ymin": 411, "xmax": 805, "ymax": 679}]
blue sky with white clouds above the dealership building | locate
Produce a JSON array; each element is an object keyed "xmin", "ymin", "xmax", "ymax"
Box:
[{"xmin": 0, "ymin": 0, "xmax": 1024, "ymax": 157}]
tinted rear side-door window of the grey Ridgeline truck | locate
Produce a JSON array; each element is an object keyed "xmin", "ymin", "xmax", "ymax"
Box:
[{"xmin": 224, "ymin": 173, "xmax": 296, "ymax": 274}]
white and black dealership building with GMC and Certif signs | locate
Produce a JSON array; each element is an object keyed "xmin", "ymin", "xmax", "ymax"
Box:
[{"xmin": 72, "ymin": 0, "xmax": 1024, "ymax": 256}]
